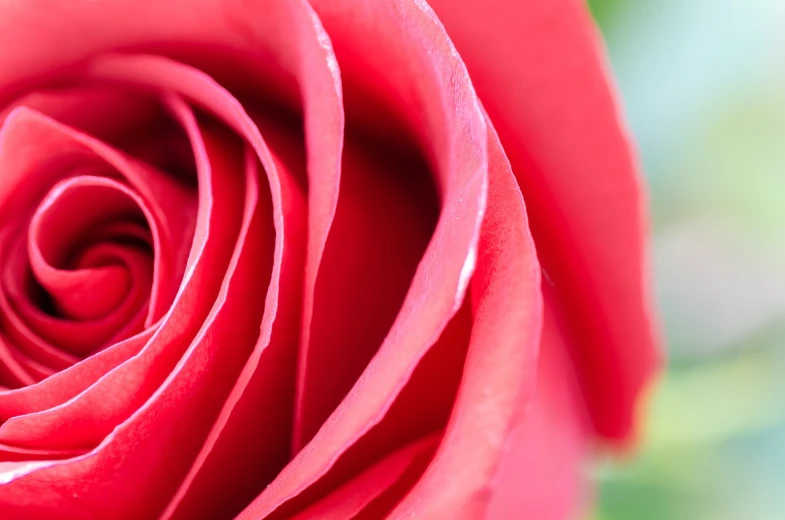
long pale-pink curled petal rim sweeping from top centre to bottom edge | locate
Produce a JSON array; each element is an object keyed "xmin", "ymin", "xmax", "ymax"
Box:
[{"xmin": 238, "ymin": 1, "xmax": 487, "ymax": 518}]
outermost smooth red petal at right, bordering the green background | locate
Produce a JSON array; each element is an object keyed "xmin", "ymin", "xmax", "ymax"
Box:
[{"xmin": 431, "ymin": 0, "xmax": 657, "ymax": 439}]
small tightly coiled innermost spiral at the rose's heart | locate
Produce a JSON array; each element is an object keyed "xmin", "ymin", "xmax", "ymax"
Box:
[{"xmin": 27, "ymin": 178, "xmax": 153, "ymax": 321}]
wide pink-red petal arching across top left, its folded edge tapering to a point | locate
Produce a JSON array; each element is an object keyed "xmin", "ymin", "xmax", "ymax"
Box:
[{"xmin": 0, "ymin": 0, "xmax": 343, "ymax": 438}]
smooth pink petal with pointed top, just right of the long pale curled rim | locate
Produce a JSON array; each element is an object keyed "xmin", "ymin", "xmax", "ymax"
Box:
[{"xmin": 393, "ymin": 116, "xmax": 543, "ymax": 519}]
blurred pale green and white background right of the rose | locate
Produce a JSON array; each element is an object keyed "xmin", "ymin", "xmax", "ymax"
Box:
[{"xmin": 589, "ymin": 0, "xmax": 785, "ymax": 520}]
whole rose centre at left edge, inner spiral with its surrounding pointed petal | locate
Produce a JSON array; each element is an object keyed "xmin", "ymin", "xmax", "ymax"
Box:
[{"xmin": 0, "ymin": 108, "xmax": 193, "ymax": 388}]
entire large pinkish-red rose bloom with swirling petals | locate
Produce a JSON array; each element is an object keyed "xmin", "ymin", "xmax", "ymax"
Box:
[{"xmin": 0, "ymin": 0, "xmax": 656, "ymax": 520}]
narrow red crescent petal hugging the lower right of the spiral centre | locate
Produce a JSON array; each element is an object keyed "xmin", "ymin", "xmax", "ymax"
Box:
[{"xmin": 0, "ymin": 102, "xmax": 244, "ymax": 449}]
